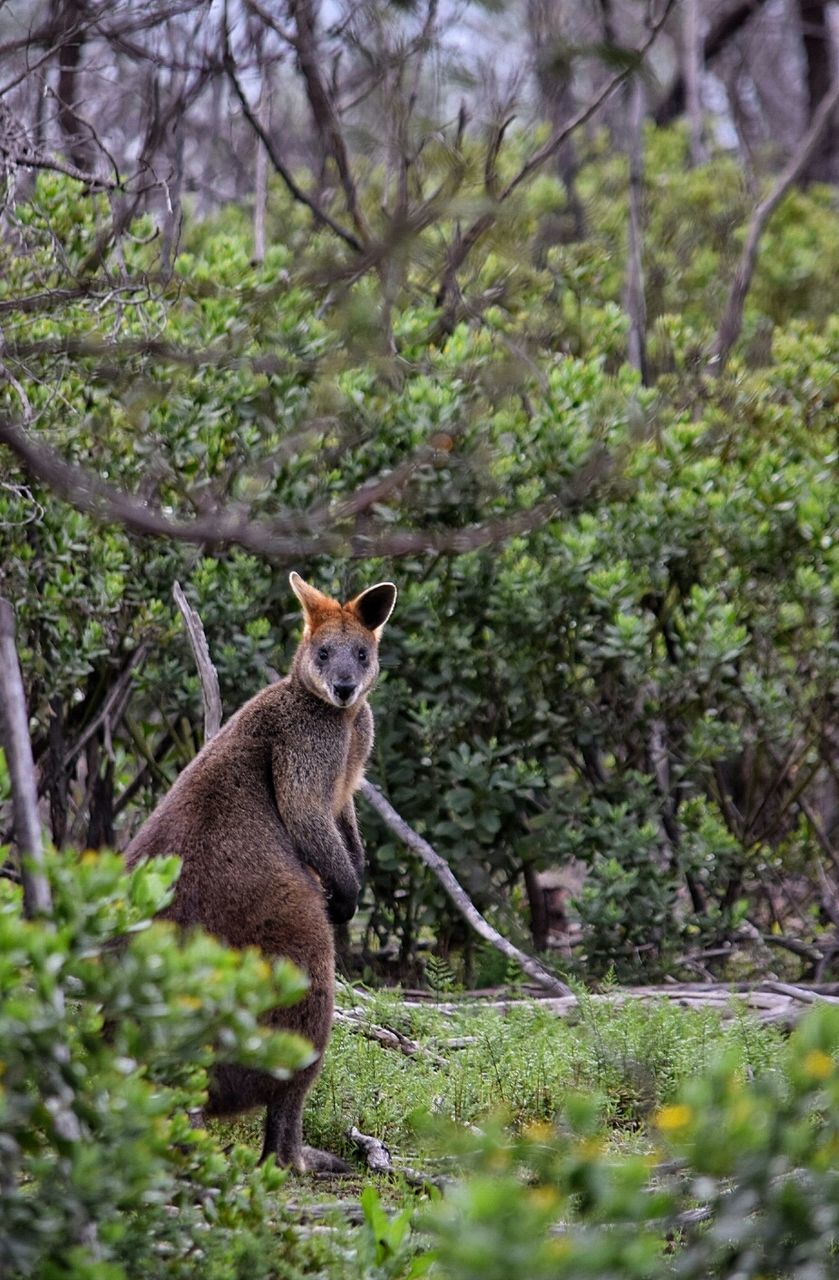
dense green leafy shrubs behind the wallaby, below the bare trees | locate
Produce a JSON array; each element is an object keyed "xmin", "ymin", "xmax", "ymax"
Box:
[{"xmin": 0, "ymin": 131, "xmax": 839, "ymax": 979}]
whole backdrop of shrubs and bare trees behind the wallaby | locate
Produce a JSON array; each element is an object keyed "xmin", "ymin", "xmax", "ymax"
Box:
[{"xmin": 0, "ymin": 0, "xmax": 839, "ymax": 982}]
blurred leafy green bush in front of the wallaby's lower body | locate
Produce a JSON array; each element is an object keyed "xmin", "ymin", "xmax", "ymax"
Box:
[{"xmin": 0, "ymin": 854, "xmax": 311, "ymax": 1280}]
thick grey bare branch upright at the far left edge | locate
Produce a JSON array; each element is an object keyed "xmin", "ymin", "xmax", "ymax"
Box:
[{"xmin": 0, "ymin": 596, "xmax": 53, "ymax": 918}]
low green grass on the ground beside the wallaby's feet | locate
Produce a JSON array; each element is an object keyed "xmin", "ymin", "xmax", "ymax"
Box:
[{"xmin": 215, "ymin": 991, "xmax": 784, "ymax": 1280}]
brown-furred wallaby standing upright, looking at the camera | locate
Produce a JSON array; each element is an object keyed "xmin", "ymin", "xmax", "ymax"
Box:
[{"xmin": 126, "ymin": 573, "xmax": 396, "ymax": 1171}]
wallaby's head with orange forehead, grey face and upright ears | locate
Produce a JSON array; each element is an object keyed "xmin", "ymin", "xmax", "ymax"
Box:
[{"xmin": 289, "ymin": 573, "xmax": 396, "ymax": 707}]
